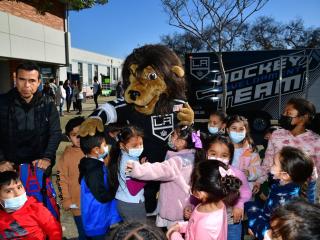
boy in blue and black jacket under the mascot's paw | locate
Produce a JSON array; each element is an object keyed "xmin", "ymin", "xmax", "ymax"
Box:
[{"xmin": 79, "ymin": 124, "xmax": 121, "ymax": 240}]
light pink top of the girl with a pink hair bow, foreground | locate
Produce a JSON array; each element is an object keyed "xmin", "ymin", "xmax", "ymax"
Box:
[{"xmin": 170, "ymin": 206, "xmax": 228, "ymax": 240}]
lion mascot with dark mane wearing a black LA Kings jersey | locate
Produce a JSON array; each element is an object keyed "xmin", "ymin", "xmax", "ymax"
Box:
[{"xmin": 80, "ymin": 45, "xmax": 194, "ymax": 213}]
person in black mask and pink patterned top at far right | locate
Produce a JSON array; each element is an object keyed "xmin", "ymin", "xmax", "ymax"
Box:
[{"xmin": 258, "ymin": 98, "xmax": 320, "ymax": 203}]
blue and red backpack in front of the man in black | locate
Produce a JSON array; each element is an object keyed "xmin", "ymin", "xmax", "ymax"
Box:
[{"xmin": 19, "ymin": 164, "xmax": 60, "ymax": 221}]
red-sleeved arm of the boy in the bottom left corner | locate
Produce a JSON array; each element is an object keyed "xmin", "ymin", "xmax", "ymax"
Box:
[{"xmin": 32, "ymin": 203, "xmax": 62, "ymax": 240}]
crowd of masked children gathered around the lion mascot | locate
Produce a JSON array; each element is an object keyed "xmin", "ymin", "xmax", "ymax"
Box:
[{"xmin": 0, "ymin": 96, "xmax": 320, "ymax": 240}]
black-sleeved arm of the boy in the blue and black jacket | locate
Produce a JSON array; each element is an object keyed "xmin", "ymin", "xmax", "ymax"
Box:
[{"xmin": 85, "ymin": 168, "xmax": 115, "ymax": 203}]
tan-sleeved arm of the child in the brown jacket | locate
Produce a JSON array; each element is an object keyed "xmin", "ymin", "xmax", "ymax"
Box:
[{"xmin": 57, "ymin": 149, "xmax": 72, "ymax": 210}]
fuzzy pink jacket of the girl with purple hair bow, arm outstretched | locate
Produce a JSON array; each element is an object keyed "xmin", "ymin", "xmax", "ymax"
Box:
[{"xmin": 130, "ymin": 149, "xmax": 194, "ymax": 221}]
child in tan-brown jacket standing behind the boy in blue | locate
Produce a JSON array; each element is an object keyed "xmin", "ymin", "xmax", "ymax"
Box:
[{"xmin": 57, "ymin": 117, "xmax": 86, "ymax": 240}]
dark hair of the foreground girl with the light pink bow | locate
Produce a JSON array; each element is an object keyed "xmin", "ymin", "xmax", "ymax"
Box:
[{"xmin": 191, "ymin": 160, "xmax": 242, "ymax": 206}]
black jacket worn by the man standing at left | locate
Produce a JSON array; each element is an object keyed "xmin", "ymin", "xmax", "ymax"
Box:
[{"xmin": 0, "ymin": 88, "xmax": 62, "ymax": 166}]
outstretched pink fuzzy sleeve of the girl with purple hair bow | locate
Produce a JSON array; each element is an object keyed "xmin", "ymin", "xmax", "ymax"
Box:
[{"xmin": 129, "ymin": 157, "xmax": 182, "ymax": 181}]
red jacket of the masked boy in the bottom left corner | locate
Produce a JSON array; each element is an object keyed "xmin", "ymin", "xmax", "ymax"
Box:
[{"xmin": 0, "ymin": 197, "xmax": 62, "ymax": 240}]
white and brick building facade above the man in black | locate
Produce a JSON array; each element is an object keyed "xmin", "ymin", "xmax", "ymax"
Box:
[{"xmin": 0, "ymin": 0, "xmax": 70, "ymax": 93}]
